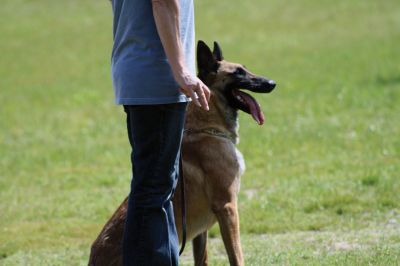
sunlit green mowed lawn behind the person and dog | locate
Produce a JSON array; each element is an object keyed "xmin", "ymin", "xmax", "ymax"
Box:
[{"xmin": 0, "ymin": 0, "xmax": 400, "ymax": 265}]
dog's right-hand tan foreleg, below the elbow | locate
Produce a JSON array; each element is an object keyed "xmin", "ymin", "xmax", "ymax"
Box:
[{"xmin": 213, "ymin": 201, "xmax": 244, "ymax": 266}]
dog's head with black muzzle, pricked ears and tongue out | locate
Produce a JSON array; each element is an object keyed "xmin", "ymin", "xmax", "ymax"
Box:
[{"xmin": 197, "ymin": 41, "xmax": 276, "ymax": 125}]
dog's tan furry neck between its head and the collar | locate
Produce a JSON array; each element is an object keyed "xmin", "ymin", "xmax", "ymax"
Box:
[{"xmin": 185, "ymin": 93, "xmax": 239, "ymax": 144}]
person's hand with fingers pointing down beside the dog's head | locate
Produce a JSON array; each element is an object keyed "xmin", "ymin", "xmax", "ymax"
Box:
[{"xmin": 175, "ymin": 71, "xmax": 210, "ymax": 111}]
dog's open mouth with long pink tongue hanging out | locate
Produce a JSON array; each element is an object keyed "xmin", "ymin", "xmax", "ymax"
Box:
[{"xmin": 232, "ymin": 89, "xmax": 265, "ymax": 125}]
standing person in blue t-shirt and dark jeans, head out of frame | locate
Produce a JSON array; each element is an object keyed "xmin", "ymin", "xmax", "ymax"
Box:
[{"xmin": 111, "ymin": 0, "xmax": 210, "ymax": 266}]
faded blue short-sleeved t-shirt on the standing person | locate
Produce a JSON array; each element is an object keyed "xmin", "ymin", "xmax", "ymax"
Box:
[{"xmin": 111, "ymin": 0, "xmax": 195, "ymax": 105}]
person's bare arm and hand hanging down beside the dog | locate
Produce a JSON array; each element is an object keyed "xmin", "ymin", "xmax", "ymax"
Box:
[{"xmin": 151, "ymin": 0, "xmax": 210, "ymax": 110}]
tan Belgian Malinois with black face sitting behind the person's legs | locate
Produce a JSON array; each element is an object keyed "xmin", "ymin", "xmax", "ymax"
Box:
[{"xmin": 89, "ymin": 41, "xmax": 275, "ymax": 266}]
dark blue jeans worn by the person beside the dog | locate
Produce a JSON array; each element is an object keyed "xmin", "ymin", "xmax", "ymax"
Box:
[{"xmin": 123, "ymin": 103, "xmax": 186, "ymax": 266}]
